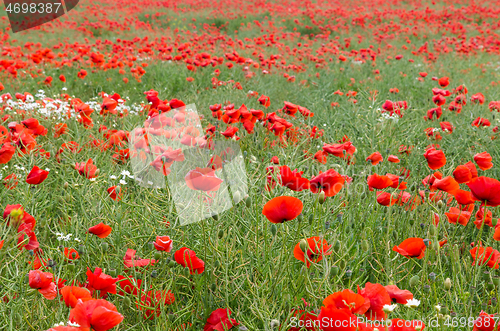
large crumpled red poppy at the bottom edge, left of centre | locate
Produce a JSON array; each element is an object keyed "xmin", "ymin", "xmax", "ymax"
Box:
[{"xmin": 69, "ymin": 299, "xmax": 123, "ymax": 331}]
